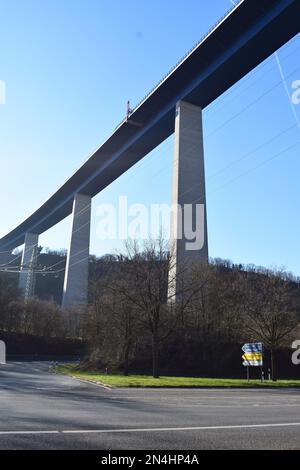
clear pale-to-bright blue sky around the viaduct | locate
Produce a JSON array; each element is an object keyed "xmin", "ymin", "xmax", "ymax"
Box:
[{"xmin": 0, "ymin": 0, "xmax": 300, "ymax": 274}]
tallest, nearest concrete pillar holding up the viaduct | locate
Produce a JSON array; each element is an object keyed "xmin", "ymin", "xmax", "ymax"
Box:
[{"xmin": 169, "ymin": 101, "xmax": 208, "ymax": 300}]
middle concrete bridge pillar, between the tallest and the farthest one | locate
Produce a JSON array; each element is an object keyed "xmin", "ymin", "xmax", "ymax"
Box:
[{"xmin": 62, "ymin": 194, "xmax": 91, "ymax": 308}]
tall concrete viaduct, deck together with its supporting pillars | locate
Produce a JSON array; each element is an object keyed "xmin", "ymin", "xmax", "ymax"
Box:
[{"xmin": 0, "ymin": 0, "xmax": 300, "ymax": 307}]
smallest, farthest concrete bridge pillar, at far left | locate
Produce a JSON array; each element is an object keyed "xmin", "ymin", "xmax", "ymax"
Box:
[{"xmin": 19, "ymin": 233, "xmax": 39, "ymax": 299}]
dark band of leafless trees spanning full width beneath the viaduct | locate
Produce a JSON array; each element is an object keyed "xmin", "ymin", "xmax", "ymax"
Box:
[{"xmin": 0, "ymin": 240, "xmax": 300, "ymax": 380}]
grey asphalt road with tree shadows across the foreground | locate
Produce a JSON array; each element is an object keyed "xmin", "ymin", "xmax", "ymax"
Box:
[{"xmin": 0, "ymin": 363, "xmax": 300, "ymax": 450}]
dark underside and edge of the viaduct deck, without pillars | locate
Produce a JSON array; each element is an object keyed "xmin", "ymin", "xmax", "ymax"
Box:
[{"xmin": 0, "ymin": 0, "xmax": 300, "ymax": 250}]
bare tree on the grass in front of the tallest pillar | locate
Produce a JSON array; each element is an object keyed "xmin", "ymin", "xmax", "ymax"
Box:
[{"xmin": 101, "ymin": 238, "xmax": 206, "ymax": 378}]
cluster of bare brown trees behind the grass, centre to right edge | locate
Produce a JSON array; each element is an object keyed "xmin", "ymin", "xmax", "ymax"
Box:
[{"xmin": 83, "ymin": 241, "xmax": 300, "ymax": 380}]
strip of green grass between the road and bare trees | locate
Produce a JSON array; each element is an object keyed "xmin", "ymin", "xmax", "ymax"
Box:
[{"xmin": 54, "ymin": 365, "xmax": 300, "ymax": 388}]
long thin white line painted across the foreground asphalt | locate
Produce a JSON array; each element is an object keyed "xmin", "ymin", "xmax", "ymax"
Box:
[{"xmin": 0, "ymin": 423, "xmax": 300, "ymax": 436}]
